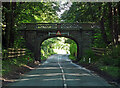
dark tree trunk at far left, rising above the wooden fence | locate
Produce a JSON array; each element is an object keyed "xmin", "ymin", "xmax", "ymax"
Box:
[{"xmin": 3, "ymin": 2, "xmax": 16, "ymax": 48}]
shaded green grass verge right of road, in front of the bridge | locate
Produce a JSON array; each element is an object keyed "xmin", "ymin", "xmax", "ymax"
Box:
[{"xmin": 79, "ymin": 58, "xmax": 120, "ymax": 78}]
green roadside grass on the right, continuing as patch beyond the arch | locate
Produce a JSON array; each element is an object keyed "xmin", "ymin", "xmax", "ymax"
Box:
[{"xmin": 69, "ymin": 55, "xmax": 120, "ymax": 79}]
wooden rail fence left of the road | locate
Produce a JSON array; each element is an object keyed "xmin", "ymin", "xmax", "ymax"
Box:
[{"xmin": 2, "ymin": 48, "xmax": 26, "ymax": 60}]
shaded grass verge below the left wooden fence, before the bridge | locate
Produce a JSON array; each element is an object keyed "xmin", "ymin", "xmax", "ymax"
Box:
[{"xmin": 2, "ymin": 54, "xmax": 33, "ymax": 76}]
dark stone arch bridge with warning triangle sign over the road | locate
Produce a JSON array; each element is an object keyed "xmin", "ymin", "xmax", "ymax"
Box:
[{"xmin": 19, "ymin": 23, "xmax": 98, "ymax": 61}]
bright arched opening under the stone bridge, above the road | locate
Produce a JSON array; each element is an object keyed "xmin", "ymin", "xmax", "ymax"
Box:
[{"xmin": 40, "ymin": 37, "xmax": 79, "ymax": 60}]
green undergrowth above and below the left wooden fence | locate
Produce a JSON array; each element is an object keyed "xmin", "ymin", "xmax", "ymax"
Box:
[{"xmin": 2, "ymin": 31, "xmax": 34, "ymax": 75}]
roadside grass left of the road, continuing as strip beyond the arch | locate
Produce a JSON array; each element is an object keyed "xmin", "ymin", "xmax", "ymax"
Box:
[{"xmin": 2, "ymin": 49, "xmax": 56, "ymax": 76}]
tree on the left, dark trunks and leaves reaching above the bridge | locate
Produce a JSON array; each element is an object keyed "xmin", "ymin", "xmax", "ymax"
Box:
[{"xmin": 2, "ymin": 2, "xmax": 59, "ymax": 48}]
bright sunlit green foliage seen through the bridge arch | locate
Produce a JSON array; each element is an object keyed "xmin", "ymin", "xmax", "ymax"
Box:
[{"xmin": 41, "ymin": 37, "xmax": 71, "ymax": 59}]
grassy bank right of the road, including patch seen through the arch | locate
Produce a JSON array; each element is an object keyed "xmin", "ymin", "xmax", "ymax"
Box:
[{"xmin": 69, "ymin": 55, "xmax": 120, "ymax": 82}]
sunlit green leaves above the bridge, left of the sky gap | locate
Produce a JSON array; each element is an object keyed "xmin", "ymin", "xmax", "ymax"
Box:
[{"xmin": 16, "ymin": 2, "xmax": 60, "ymax": 23}]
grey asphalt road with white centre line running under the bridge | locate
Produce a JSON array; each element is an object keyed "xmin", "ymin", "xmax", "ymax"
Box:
[{"xmin": 5, "ymin": 54, "xmax": 111, "ymax": 88}]
